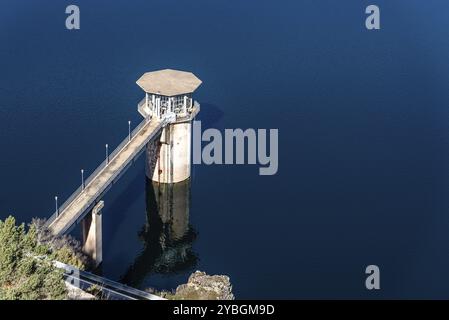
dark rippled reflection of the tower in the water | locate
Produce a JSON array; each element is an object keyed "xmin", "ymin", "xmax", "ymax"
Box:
[{"xmin": 121, "ymin": 179, "xmax": 198, "ymax": 287}]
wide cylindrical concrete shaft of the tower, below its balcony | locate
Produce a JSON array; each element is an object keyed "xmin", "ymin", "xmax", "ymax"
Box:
[{"xmin": 147, "ymin": 121, "xmax": 192, "ymax": 183}]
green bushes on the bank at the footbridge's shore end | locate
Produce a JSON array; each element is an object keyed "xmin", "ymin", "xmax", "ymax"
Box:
[{"xmin": 0, "ymin": 216, "xmax": 83, "ymax": 300}]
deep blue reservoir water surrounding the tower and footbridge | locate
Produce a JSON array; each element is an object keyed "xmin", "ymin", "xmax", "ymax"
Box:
[{"xmin": 0, "ymin": 0, "xmax": 449, "ymax": 298}]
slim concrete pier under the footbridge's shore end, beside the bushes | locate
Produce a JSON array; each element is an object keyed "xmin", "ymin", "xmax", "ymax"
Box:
[{"xmin": 81, "ymin": 201, "xmax": 104, "ymax": 267}]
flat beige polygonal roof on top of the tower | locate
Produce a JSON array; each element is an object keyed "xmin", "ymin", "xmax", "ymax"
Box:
[{"xmin": 136, "ymin": 69, "xmax": 202, "ymax": 97}]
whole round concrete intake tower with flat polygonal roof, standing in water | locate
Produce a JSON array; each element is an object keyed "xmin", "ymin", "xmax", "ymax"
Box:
[{"xmin": 137, "ymin": 69, "xmax": 201, "ymax": 183}]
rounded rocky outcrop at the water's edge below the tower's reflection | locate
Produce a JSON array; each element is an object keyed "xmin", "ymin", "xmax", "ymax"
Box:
[{"xmin": 172, "ymin": 271, "xmax": 234, "ymax": 300}]
